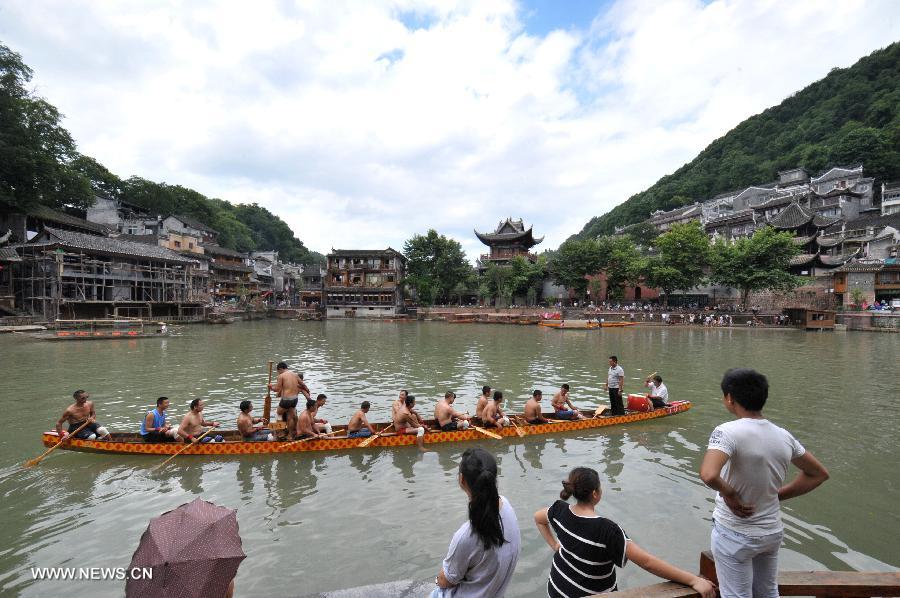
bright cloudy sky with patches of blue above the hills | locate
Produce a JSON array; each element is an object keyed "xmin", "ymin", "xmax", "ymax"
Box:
[{"xmin": 0, "ymin": 0, "xmax": 900, "ymax": 259}]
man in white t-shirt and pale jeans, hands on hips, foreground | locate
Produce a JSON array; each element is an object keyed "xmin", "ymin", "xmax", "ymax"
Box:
[{"xmin": 700, "ymin": 368, "xmax": 828, "ymax": 598}]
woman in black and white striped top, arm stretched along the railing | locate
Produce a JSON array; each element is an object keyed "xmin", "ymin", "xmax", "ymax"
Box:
[{"xmin": 534, "ymin": 467, "xmax": 716, "ymax": 598}]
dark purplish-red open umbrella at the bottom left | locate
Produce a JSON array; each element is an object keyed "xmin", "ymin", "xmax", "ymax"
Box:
[{"xmin": 125, "ymin": 498, "xmax": 247, "ymax": 598}]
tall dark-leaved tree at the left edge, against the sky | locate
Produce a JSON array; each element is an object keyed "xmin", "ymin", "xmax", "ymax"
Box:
[{"xmin": 0, "ymin": 45, "xmax": 94, "ymax": 210}]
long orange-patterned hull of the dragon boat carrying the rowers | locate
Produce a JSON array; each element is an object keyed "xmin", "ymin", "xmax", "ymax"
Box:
[{"xmin": 42, "ymin": 401, "xmax": 691, "ymax": 455}]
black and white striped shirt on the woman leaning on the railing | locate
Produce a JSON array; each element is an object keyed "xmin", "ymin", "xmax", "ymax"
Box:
[{"xmin": 547, "ymin": 500, "xmax": 628, "ymax": 598}]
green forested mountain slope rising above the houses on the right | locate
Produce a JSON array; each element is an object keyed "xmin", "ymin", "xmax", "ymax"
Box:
[{"xmin": 573, "ymin": 42, "xmax": 900, "ymax": 239}]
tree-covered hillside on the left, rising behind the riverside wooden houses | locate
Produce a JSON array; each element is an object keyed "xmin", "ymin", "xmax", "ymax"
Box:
[{"xmin": 0, "ymin": 44, "xmax": 324, "ymax": 263}]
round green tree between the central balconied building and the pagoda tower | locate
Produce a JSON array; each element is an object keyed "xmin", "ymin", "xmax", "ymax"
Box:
[{"xmin": 403, "ymin": 229, "xmax": 472, "ymax": 305}]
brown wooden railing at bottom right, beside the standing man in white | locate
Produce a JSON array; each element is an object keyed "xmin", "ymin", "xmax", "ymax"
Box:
[{"xmin": 617, "ymin": 550, "xmax": 900, "ymax": 598}]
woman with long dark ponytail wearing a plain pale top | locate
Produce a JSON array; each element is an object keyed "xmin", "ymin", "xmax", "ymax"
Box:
[{"xmin": 431, "ymin": 448, "xmax": 521, "ymax": 598}]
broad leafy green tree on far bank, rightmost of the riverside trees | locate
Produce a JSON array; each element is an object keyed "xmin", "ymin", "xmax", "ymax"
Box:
[{"xmin": 710, "ymin": 226, "xmax": 803, "ymax": 308}]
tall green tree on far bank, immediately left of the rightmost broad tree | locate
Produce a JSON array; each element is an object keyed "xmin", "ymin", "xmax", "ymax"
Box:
[{"xmin": 646, "ymin": 222, "xmax": 710, "ymax": 305}]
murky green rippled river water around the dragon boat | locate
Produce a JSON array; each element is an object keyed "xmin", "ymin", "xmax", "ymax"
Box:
[{"xmin": 0, "ymin": 321, "xmax": 900, "ymax": 596}]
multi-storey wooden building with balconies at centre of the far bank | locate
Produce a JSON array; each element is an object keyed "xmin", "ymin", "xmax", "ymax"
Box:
[{"xmin": 323, "ymin": 247, "xmax": 406, "ymax": 318}]
